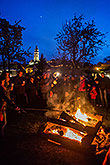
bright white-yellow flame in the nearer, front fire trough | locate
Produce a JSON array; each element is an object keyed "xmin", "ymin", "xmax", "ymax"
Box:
[{"xmin": 63, "ymin": 128, "xmax": 82, "ymax": 142}]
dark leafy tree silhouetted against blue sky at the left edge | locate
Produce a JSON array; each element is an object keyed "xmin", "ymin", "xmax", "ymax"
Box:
[{"xmin": 0, "ymin": 18, "xmax": 31, "ymax": 71}]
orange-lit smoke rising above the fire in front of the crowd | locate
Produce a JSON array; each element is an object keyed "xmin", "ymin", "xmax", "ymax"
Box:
[{"xmin": 45, "ymin": 76, "xmax": 96, "ymax": 118}]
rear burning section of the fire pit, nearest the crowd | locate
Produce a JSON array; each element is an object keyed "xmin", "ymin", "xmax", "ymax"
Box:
[{"xmin": 59, "ymin": 109, "xmax": 103, "ymax": 134}]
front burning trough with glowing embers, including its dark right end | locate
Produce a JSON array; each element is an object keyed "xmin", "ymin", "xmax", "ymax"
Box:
[{"xmin": 37, "ymin": 121, "xmax": 101, "ymax": 151}]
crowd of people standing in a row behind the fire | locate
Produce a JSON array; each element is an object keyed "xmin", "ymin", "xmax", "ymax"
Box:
[{"xmin": 0, "ymin": 71, "xmax": 110, "ymax": 137}]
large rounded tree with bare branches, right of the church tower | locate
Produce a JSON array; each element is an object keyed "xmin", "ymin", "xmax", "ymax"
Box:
[{"xmin": 55, "ymin": 15, "xmax": 107, "ymax": 67}]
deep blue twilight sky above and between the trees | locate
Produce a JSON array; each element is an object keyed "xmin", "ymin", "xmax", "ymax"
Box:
[{"xmin": 0, "ymin": 0, "xmax": 110, "ymax": 63}]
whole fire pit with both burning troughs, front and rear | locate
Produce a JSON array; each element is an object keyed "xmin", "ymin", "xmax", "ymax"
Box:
[{"xmin": 37, "ymin": 111, "xmax": 103, "ymax": 151}]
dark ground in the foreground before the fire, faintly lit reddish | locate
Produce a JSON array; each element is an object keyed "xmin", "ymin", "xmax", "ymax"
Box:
[{"xmin": 0, "ymin": 109, "xmax": 105, "ymax": 165}]
